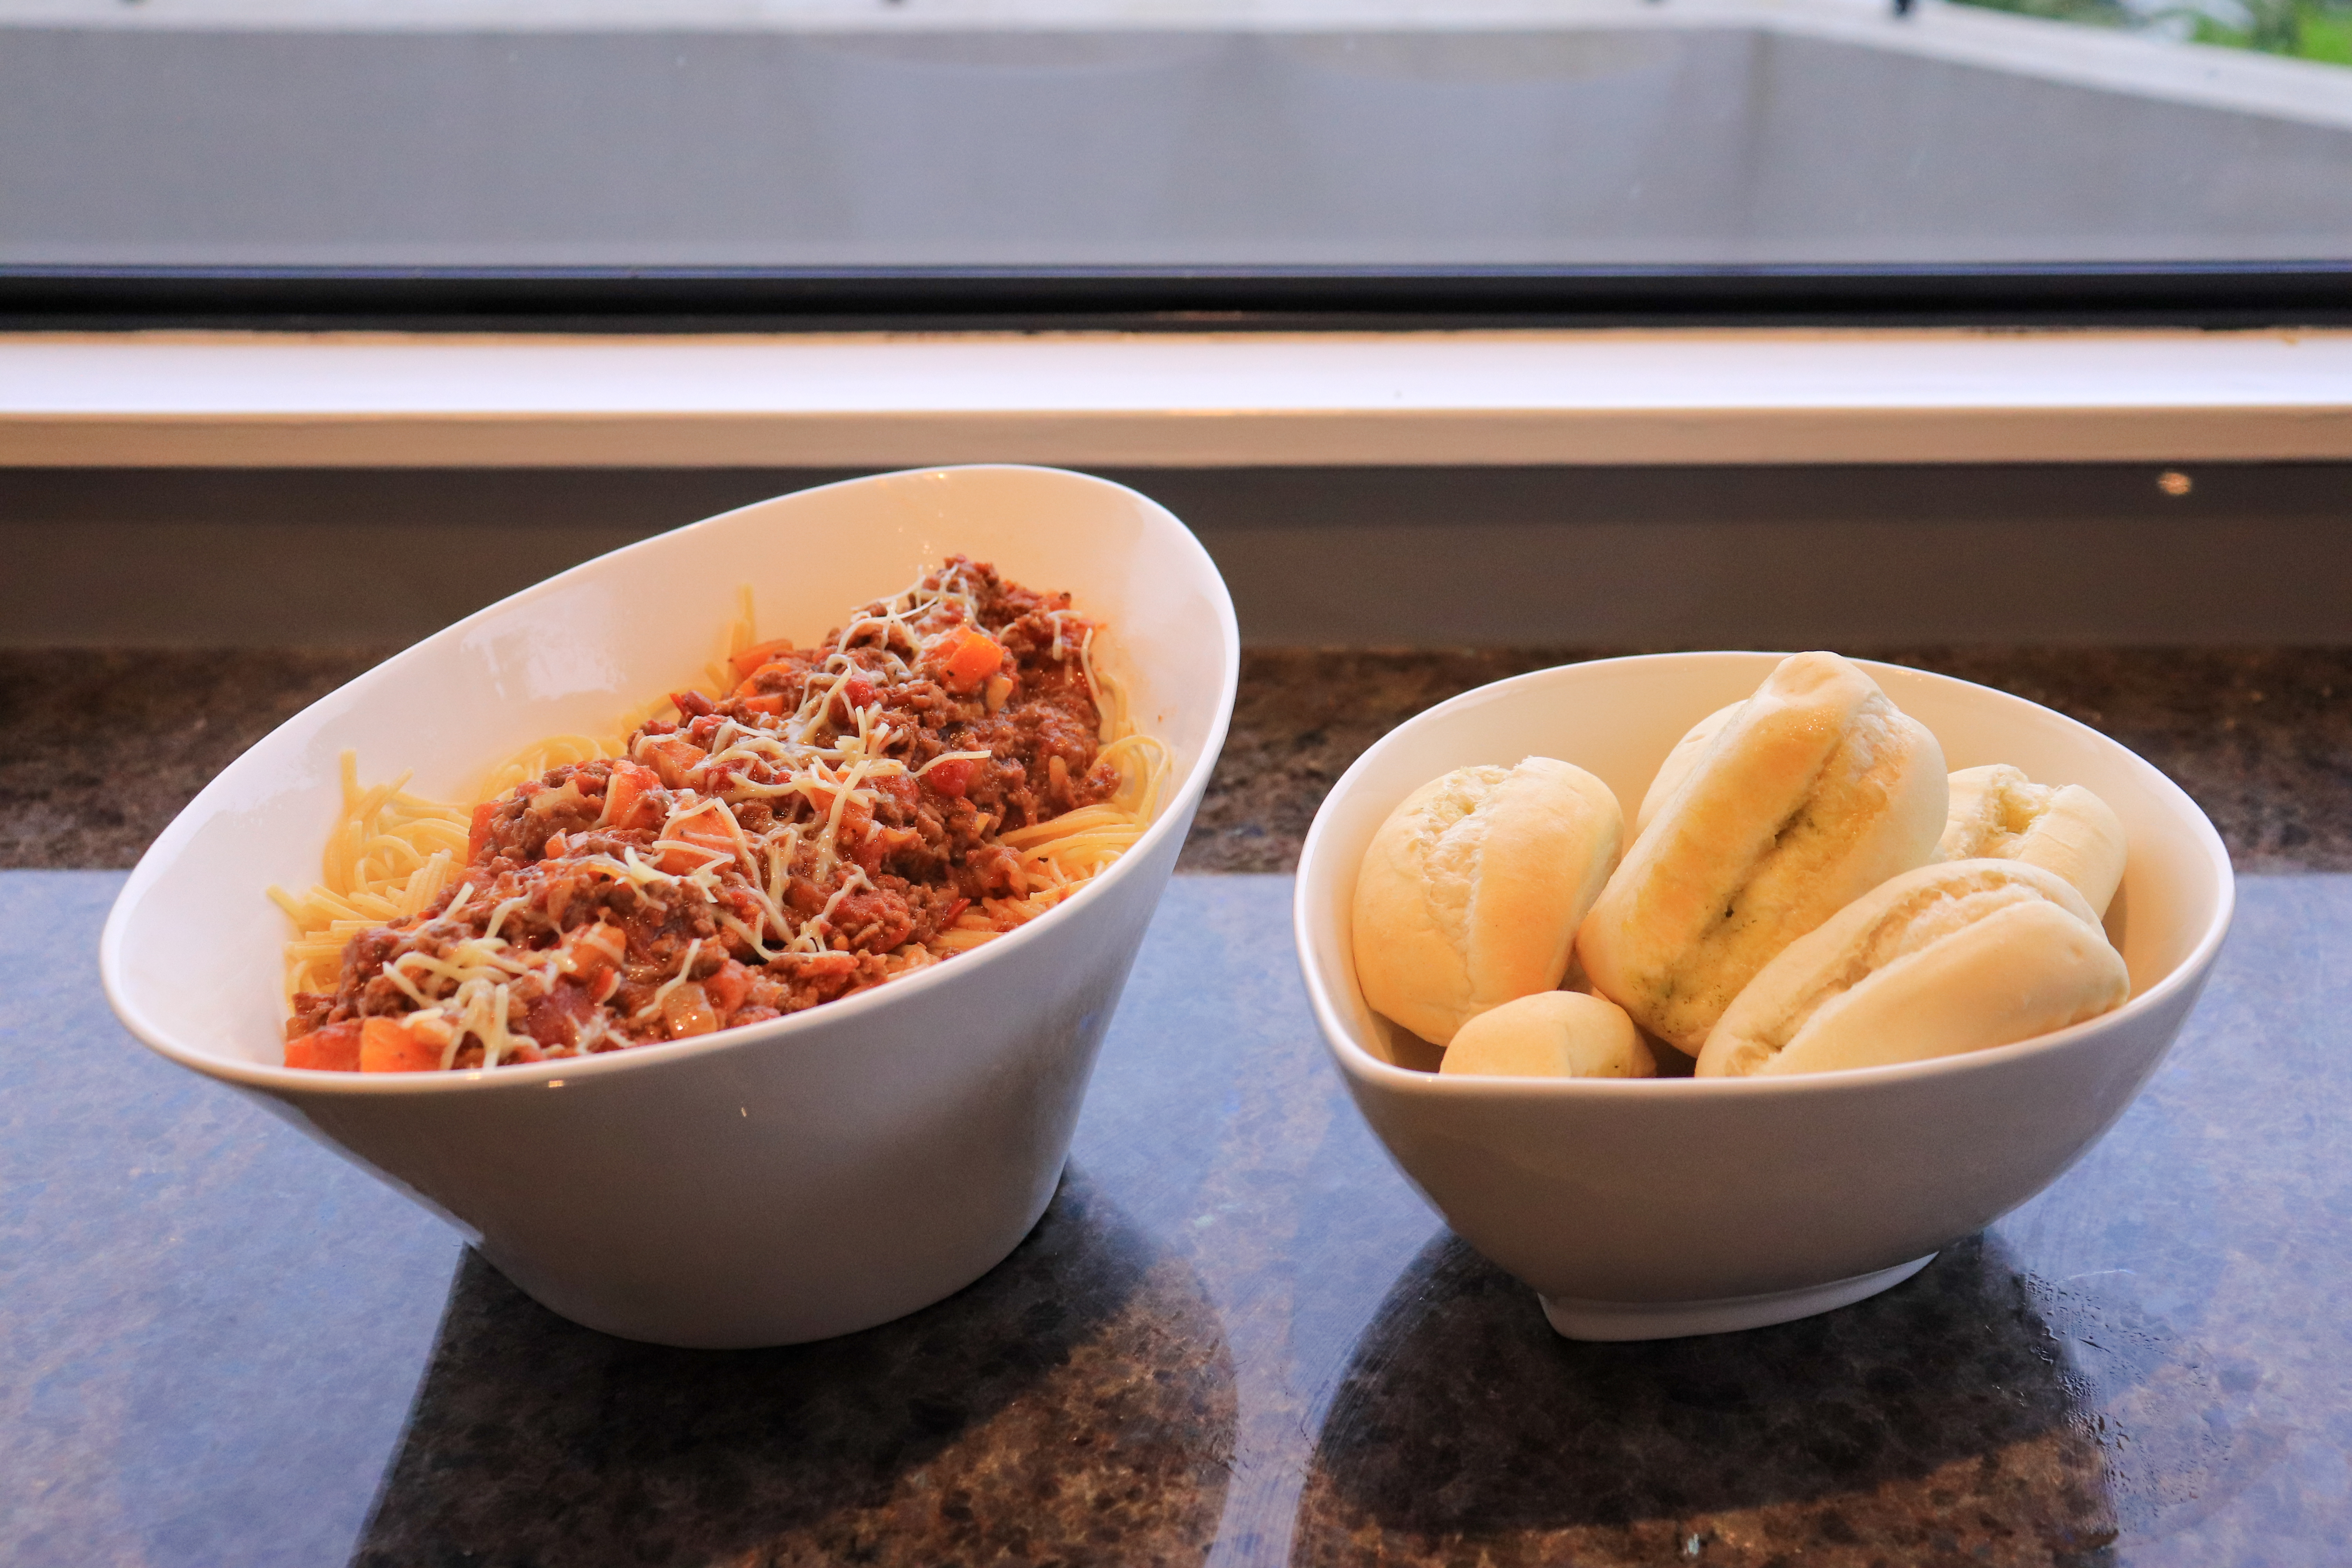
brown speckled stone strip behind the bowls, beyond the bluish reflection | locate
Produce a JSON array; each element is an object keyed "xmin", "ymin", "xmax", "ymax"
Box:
[{"xmin": 0, "ymin": 649, "xmax": 2352, "ymax": 872}]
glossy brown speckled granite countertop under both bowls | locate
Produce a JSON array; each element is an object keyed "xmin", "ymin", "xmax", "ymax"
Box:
[{"xmin": 0, "ymin": 649, "xmax": 2352, "ymax": 1568}]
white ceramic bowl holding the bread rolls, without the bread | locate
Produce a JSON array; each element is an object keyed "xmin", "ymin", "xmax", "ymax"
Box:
[{"xmin": 1296, "ymin": 653, "xmax": 2234, "ymax": 1340}]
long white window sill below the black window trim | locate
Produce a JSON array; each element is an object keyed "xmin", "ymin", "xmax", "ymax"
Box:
[{"xmin": 0, "ymin": 329, "xmax": 2352, "ymax": 468}]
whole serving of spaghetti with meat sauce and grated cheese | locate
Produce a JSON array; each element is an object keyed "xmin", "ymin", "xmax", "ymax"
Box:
[{"xmin": 270, "ymin": 557, "xmax": 1169, "ymax": 1070}]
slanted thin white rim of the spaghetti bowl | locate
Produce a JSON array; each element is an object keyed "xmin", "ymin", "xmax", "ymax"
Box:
[{"xmin": 99, "ymin": 463, "xmax": 1242, "ymax": 1098}]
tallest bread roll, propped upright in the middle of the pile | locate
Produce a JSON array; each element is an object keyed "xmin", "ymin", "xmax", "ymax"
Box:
[{"xmin": 1576, "ymin": 653, "xmax": 1945, "ymax": 1056}]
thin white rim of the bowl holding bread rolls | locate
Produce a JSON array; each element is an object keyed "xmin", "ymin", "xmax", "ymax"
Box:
[{"xmin": 1291, "ymin": 649, "xmax": 2237, "ymax": 1100}]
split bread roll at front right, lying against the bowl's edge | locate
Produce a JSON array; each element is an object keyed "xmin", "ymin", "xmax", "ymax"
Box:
[{"xmin": 1698, "ymin": 860, "xmax": 2131, "ymax": 1077}]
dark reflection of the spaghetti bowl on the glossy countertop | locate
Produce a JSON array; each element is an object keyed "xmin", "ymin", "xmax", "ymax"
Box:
[{"xmin": 353, "ymin": 1164, "xmax": 1232, "ymax": 1568}]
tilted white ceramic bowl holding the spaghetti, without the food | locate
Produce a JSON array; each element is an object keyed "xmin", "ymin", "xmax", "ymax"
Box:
[{"xmin": 101, "ymin": 468, "xmax": 1240, "ymax": 1347}]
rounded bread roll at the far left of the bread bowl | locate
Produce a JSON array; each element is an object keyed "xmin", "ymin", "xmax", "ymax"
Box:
[{"xmin": 1355, "ymin": 757, "xmax": 1625, "ymax": 1046}]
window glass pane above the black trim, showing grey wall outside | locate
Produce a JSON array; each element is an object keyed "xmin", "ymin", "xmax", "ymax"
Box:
[{"xmin": 0, "ymin": 0, "xmax": 2352, "ymax": 268}]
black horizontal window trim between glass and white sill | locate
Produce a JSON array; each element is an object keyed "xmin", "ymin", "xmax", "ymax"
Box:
[{"xmin": 14, "ymin": 261, "xmax": 2352, "ymax": 334}]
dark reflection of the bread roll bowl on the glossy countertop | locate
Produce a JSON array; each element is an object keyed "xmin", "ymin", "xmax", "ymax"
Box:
[{"xmin": 1294, "ymin": 1236, "xmax": 2117, "ymax": 1568}]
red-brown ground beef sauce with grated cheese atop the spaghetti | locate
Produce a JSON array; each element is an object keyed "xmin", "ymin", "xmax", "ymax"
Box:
[{"xmin": 289, "ymin": 557, "xmax": 1120, "ymax": 1067}]
